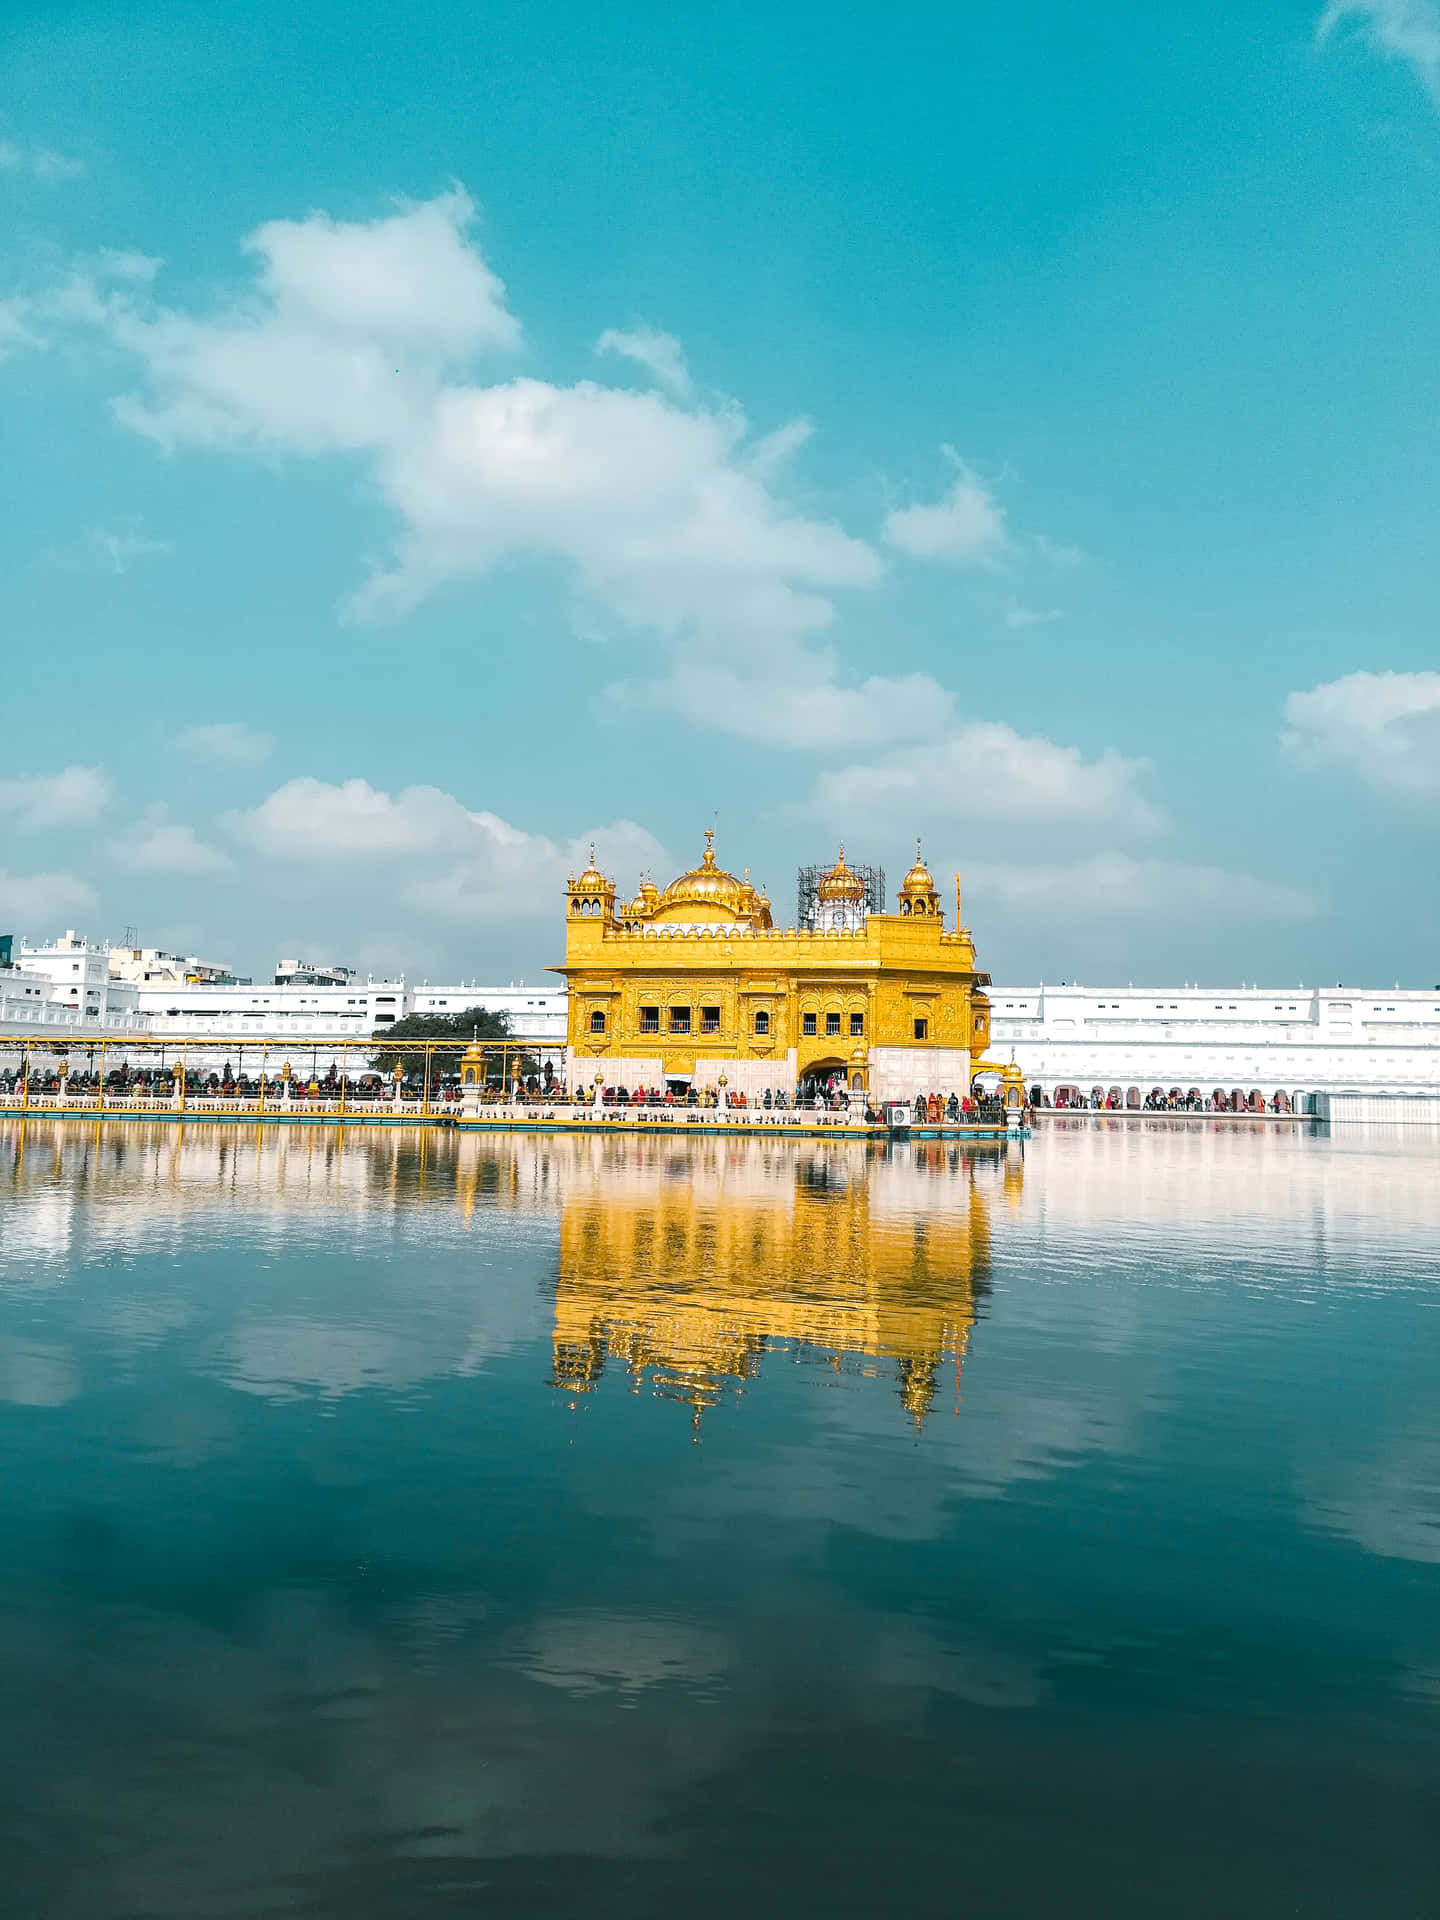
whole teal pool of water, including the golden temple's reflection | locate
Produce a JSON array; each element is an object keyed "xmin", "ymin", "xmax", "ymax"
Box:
[{"xmin": 0, "ymin": 1116, "xmax": 1440, "ymax": 1920}]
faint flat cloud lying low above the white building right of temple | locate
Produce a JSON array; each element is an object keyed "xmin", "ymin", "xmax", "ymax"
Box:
[{"xmin": 966, "ymin": 852, "xmax": 1321, "ymax": 922}]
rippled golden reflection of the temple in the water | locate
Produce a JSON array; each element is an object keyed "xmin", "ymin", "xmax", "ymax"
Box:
[{"xmin": 553, "ymin": 1140, "xmax": 1021, "ymax": 1425}]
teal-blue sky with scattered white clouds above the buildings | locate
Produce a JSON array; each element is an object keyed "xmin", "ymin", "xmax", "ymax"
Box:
[{"xmin": 0, "ymin": 0, "xmax": 1440, "ymax": 985}]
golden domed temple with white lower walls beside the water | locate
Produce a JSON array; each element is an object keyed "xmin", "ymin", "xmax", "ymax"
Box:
[{"xmin": 553, "ymin": 833, "xmax": 991, "ymax": 1100}]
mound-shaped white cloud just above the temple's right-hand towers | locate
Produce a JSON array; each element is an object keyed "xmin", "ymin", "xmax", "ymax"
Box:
[{"xmin": 810, "ymin": 720, "xmax": 1167, "ymax": 835}]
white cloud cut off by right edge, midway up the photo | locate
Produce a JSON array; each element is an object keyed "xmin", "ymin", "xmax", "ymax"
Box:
[{"xmin": 1281, "ymin": 672, "xmax": 1440, "ymax": 801}]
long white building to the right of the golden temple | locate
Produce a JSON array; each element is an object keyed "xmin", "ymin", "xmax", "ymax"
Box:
[{"xmin": 989, "ymin": 987, "xmax": 1440, "ymax": 1100}]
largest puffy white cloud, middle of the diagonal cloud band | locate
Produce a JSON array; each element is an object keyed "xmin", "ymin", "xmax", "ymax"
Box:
[{"xmin": 347, "ymin": 378, "xmax": 879, "ymax": 622}]
